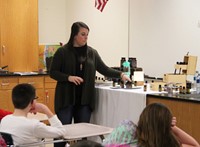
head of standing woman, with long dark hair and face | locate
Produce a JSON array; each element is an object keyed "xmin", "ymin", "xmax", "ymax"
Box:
[{"xmin": 68, "ymin": 22, "xmax": 90, "ymax": 47}]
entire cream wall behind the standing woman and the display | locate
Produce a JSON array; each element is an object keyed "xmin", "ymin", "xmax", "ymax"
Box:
[{"xmin": 39, "ymin": 0, "xmax": 200, "ymax": 77}]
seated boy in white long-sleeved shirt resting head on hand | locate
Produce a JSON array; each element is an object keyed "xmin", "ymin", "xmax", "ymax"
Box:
[{"xmin": 0, "ymin": 84, "xmax": 66, "ymax": 145}]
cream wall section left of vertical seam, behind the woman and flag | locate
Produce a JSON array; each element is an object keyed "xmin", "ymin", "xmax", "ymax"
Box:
[{"xmin": 39, "ymin": 0, "xmax": 128, "ymax": 74}]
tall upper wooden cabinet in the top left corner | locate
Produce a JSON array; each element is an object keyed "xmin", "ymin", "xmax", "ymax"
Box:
[{"xmin": 0, "ymin": 0, "xmax": 38, "ymax": 71}]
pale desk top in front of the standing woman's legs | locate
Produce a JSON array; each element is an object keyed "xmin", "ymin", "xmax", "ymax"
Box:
[{"xmin": 64, "ymin": 123, "xmax": 113, "ymax": 140}]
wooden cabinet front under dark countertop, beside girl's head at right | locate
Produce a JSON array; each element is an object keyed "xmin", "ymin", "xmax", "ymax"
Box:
[{"xmin": 147, "ymin": 95, "xmax": 200, "ymax": 142}]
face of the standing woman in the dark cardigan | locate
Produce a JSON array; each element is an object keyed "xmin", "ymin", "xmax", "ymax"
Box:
[{"xmin": 74, "ymin": 28, "xmax": 89, "ymax": 47}]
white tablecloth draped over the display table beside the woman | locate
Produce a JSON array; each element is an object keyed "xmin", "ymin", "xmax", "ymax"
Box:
[{"xmin": 91, "ymin": 86, "xmax": 159, "ymax": 128}]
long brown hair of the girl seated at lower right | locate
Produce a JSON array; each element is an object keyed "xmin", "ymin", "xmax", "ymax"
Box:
[{"xmin": 136, "ymin": 103, "xmax": 180, "ymax": 147}]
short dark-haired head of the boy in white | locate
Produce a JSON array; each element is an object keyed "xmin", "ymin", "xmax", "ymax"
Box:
[{"xmin": 12, "ymin": 83, "xmax": 35, "ymax": 109}]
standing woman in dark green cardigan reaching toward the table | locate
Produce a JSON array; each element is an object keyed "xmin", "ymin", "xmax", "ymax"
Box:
[{"xmin": 50, "ymin": 22, "xmax": 130, "ymax": 124}]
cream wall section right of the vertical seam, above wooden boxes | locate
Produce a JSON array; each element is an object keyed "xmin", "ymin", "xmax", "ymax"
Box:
[{"xmin": 130, "ymin": 0, "xmax": 200, "ymax": 77}]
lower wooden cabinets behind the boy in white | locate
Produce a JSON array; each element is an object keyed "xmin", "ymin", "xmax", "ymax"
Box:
[{"xmin": 0, "ymin": 75, "xmax": 56, "ymax": 112}]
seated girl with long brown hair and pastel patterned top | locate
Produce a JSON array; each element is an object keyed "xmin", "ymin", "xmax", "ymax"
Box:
[{"xmin": 103, "ymin": 103, "xmax": 200, "ymax": 147}]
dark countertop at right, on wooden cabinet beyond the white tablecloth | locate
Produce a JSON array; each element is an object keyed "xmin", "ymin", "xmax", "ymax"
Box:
[{"xmin": 147, "ymin": 91, "xmax": 200, "ymax": 103}]
